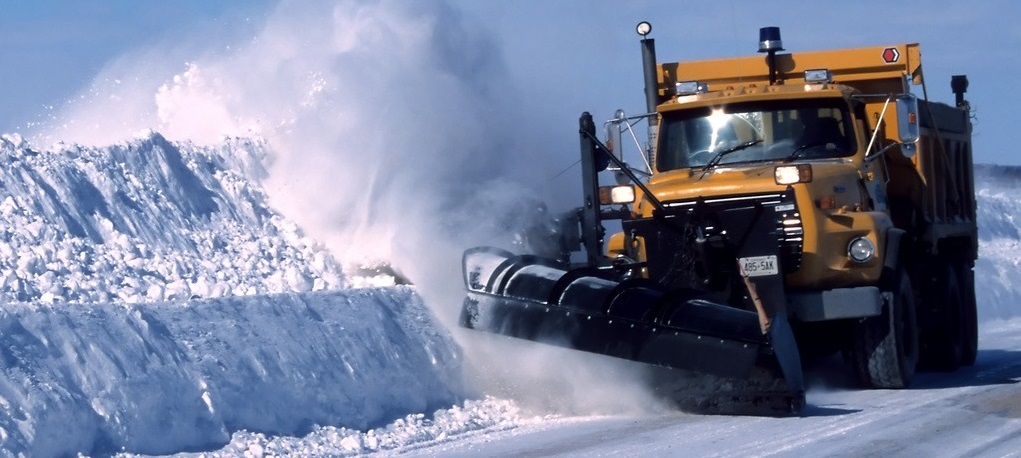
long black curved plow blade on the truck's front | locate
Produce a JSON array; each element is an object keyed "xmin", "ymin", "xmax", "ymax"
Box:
[{"xmin": 460, "ymin": 248, "xmax": 805, "ymax": 415}]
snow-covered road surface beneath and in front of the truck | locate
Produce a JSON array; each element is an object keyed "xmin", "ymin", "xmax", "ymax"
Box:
[{"xmin": 400, "ymin": 319, "xmax": 1021, "ymax": 457}]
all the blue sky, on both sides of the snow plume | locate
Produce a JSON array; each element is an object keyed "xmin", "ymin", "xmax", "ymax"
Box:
[{"xmin": 0, "ymin": 0, "xmax": 1021, "ymax": 164}]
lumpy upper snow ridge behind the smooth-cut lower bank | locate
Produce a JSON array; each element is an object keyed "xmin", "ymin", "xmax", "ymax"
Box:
[{"xmin": 0, "ymin": 133, "xmax": 344, "ymax": 303}]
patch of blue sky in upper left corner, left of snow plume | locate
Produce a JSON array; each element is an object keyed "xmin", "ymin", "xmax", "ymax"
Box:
[{"xmin": 0, "ymin": 0, "xmax": 274, "ymax": 133}]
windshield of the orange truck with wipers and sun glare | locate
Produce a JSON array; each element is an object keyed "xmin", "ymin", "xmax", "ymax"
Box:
[{"xmin": 657, "ymin": 99, "xmax": 856, "ymax": 171}]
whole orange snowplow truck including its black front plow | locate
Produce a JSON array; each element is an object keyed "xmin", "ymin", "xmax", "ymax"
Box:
[{"xmin": 465, "ymin": 22, "xmax": 978, "ymax": 412}]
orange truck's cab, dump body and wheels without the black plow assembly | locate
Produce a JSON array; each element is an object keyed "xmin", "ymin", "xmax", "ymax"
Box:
[{"xmin": 610, "ymin": 24, "xmax": 978, "ymax": 388}]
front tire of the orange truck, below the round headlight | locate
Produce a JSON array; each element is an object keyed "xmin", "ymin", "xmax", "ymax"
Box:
[{"xmin": 850, "ymin": 272, "xmax": 918, "ymax": 389}]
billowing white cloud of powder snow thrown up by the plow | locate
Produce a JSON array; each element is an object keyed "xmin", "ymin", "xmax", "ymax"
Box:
[{"xmin": 40, "ymin": 0, "xmax": 657, "ymax": 414}]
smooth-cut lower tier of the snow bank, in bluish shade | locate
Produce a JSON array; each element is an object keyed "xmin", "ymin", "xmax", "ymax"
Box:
[{"xmin": 0, "ymin": 288, "xmax": 461, "ymax": 456}]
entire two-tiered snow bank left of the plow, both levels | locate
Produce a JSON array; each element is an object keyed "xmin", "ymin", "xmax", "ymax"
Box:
[{"xmin": 0, "ymin": 133, "xmax": 464, "ymax": 456}]
